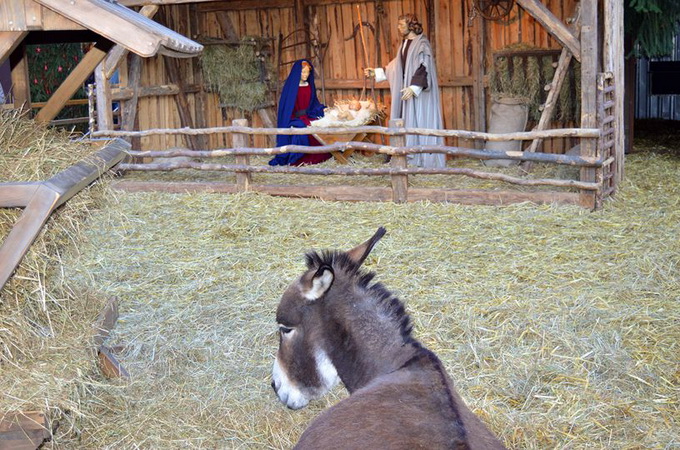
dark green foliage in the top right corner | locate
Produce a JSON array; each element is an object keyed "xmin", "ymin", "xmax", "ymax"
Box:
[{"xmin": 625, "ymin": 0, "xmax": 680, "ymax": 58}]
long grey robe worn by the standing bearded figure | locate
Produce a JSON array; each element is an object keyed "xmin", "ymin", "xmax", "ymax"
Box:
[{"xmin": 385, "ymin": 34, "xmax": 446, "ymax": 167}]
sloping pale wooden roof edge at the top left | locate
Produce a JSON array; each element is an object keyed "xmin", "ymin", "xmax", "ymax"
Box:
[{"xmin": 36, "ymin": 0, "xmax": 203, "ymax": 58}]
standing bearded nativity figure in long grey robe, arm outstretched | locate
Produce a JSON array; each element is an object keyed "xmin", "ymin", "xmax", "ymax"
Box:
[{"xmin": 366, "ymin": 14, "xmax": 446, "ymax": 168}]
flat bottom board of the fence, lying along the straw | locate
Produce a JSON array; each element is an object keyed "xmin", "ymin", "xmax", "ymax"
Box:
[{"xmin": 112, "ymin": 180, "xmax": 589, "ymax": 207}]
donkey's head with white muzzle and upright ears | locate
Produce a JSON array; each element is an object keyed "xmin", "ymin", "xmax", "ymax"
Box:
[{"xmin": 272, "ymin": 227, "xmax": 385, "ymax": 409}]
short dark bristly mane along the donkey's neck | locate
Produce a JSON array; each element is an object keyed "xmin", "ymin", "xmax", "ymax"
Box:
[{"xmin": 305, "ymin": 250, "xmax": 420, "ymax": 346}]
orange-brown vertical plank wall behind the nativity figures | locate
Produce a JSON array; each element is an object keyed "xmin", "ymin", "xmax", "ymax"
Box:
[{"xmin": 133, "ymin": 0, "xmax": 576, "ymax": 152}]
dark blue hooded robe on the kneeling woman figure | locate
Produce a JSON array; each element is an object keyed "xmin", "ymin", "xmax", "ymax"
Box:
[{"xmin": 269, "ymin": 59, "xmax": 326, "ymax": 166}]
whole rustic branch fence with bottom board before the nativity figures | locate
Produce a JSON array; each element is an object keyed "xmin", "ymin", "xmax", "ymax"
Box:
[{"xmin": 93, "ymin": 86, "xmax": 607, "ymax": 209}]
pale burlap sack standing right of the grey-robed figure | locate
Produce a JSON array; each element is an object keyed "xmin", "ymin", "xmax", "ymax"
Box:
[{"xmin": 484, "ymin": 97, "xmax": 529, "ymax": 167}]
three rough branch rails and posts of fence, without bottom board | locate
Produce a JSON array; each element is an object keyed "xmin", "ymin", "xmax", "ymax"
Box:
[{"xmin": 93, "ymin": 120, "xmax": 605, "ymax": 207}]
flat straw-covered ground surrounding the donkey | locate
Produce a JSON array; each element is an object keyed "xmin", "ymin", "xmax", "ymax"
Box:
[{"xmin": 0, "ymin": 111, "xmax": 680, "ymax": 449}]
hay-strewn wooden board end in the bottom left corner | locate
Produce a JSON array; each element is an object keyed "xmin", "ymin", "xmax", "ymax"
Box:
[{"xmin": 0, "ymin": 411, "xmax": 50, "ymax": 450}]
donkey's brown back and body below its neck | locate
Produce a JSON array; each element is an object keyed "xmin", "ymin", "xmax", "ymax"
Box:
[{"xmin": 295, "ymin": 349, "xmax": 505, "ymax": 450}]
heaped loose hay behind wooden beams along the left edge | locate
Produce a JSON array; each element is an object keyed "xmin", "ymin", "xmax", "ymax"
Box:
[{"xmin": 0, "ymin": 111, "xmax": 115, "ymax": 440}]
